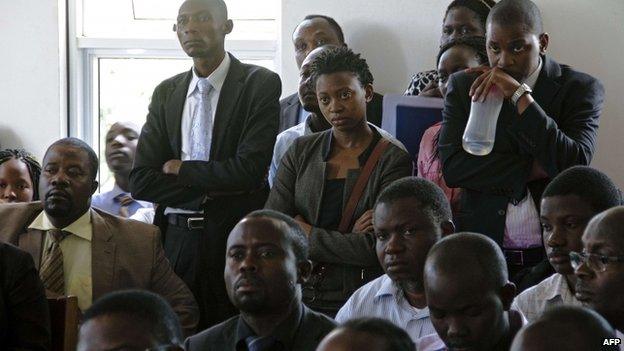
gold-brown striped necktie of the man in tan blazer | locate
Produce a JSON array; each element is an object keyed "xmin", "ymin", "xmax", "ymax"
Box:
[{"xmin": 39, "ymin": 229, "xmax": 69, "ymax": 295}]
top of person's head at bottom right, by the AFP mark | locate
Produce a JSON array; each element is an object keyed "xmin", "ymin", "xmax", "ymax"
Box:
[{"xmin": 511, "ymin": 306, "xmax": 617, "ymax": 351}]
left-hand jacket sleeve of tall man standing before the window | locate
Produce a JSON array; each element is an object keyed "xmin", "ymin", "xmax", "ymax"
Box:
[{"xmin": 130, "ymin": 81, "xmax": 204, "ymax": 209}]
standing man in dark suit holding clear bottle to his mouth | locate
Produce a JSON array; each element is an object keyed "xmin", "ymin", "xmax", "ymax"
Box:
[{"xmin": 439, "ymin": 0, "xmax": 604, "ymax": 283}]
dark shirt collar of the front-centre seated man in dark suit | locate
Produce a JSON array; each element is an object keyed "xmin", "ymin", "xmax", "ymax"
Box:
[{"xmin": 236, "ymin": 303, "xmax": 308, "ymax": 350}]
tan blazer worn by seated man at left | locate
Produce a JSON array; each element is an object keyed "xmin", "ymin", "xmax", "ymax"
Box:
[{"xmin": 0, "ymin": 202, "xmax": 199, "ymax": 335}]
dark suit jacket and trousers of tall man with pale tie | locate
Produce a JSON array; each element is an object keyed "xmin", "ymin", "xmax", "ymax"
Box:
[{"xmin": 130, "ymin": 55, "xmax": 281, "ymax": 326}]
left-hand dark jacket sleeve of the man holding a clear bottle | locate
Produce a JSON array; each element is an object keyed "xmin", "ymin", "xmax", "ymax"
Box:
[{"xmin": 438, "ymin": 74, "xmax": 531, "ymax": 199}]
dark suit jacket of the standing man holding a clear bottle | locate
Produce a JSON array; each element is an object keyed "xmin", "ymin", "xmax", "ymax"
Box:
[{"xmin": 439, "ymin": 56, "xmax": 604, "ymax": 244}]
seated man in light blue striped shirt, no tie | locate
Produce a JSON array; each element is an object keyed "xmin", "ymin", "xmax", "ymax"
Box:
[{"xmin": 336, "ymin": 177, "xmax": 454, "ymax": 341}]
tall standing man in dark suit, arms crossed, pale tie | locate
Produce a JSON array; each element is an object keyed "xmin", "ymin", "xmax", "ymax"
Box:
[{"xmin": 130, "ymin": 0, "xmax": 281, "ymax": 327}]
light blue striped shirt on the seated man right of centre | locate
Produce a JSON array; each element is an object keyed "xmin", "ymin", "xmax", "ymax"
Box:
[{"xmin": 336, "ymin": 274, "xmax": 436, "ymax": 342}]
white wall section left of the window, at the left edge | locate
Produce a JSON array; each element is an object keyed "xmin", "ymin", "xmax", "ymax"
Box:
[{"xmin": 0, "ymin": 0, "xmax": 67, "ymax": 161}]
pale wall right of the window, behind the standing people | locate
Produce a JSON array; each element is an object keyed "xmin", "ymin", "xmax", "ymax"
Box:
[{"xmin": 282, "ymin": 0, "xmax": 624, "ymax": 187}]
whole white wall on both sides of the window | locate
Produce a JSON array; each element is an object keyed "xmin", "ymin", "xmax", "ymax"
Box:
[{"xmin": 0, "ymin": 0, "xmax": 624, "ymax": 187}]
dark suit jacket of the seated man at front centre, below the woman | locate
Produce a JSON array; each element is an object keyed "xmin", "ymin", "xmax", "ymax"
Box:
[{"xmin": 184, "ymin": 305, "xmax": 336, "ymax": 351}]
